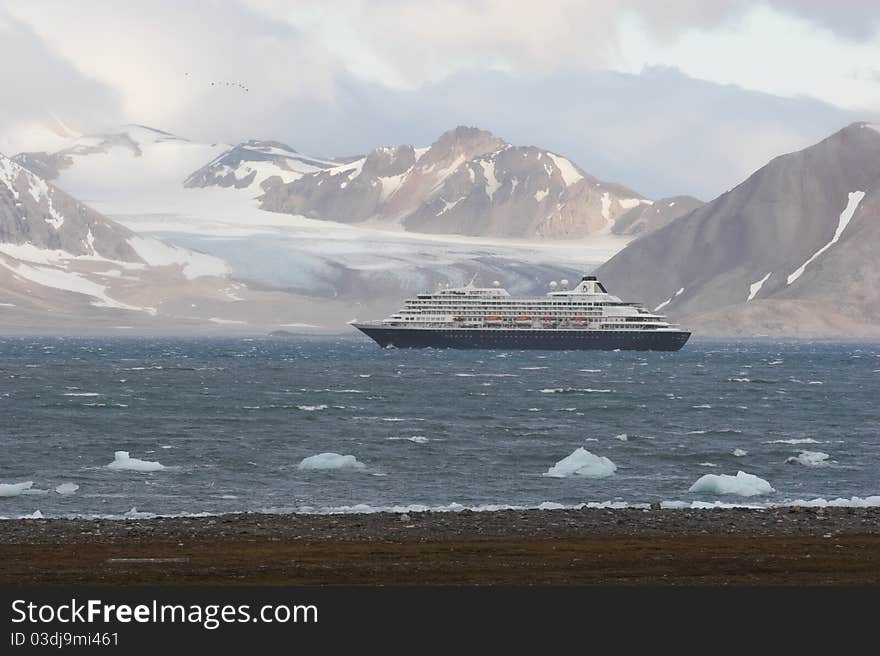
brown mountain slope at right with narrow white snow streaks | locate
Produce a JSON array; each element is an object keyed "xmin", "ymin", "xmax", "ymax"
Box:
[{"xmin": 597, "ymin": 123, "xmax": 880, "ymax": 337}]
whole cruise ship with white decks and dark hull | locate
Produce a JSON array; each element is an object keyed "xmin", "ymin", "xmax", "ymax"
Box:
[{"xmin": 351, "ymin": 276, "xmax": 691, "ymax": 351}]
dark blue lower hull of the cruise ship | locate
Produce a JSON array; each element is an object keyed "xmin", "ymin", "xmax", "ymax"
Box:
[{"xmin": 352, "ymin": 324, "xmax": 691, "ymax": 351}]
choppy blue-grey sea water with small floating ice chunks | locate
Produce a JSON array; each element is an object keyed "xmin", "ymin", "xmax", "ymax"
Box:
[{"xmin": 0, "ymin": 337, "xmax": 880, "ymax": 517}]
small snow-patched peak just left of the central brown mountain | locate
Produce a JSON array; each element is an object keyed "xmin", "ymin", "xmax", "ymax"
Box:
[{"xmin": 184, "ymin": 140, "xmax": 343, "ymax": 192}]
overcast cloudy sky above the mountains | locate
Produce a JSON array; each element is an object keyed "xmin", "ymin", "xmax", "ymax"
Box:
[{"xmin": 0, "ymin": 0, "xmax": 880, "ymax": 199}]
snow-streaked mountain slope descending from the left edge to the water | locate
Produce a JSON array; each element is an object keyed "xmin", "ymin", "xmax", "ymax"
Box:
[{"xmin": 0, "ymin": 149, "xmax": 347, "ymax": 334}]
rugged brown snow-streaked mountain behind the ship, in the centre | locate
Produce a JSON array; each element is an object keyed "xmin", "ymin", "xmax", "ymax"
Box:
[{"xmin": 261, "ymin": 127, "xmax": 650, "ymax": 239}]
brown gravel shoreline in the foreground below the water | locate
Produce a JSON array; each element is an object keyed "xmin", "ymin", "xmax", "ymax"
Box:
[{"xmin": 0, "ymin": 507, "xmax": 880, "ymax": 586}]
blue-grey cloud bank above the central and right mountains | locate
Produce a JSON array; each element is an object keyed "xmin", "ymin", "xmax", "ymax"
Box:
[{"xmin": 279, "ymin": 69, "xmax": 860, "ymax": 199}]
